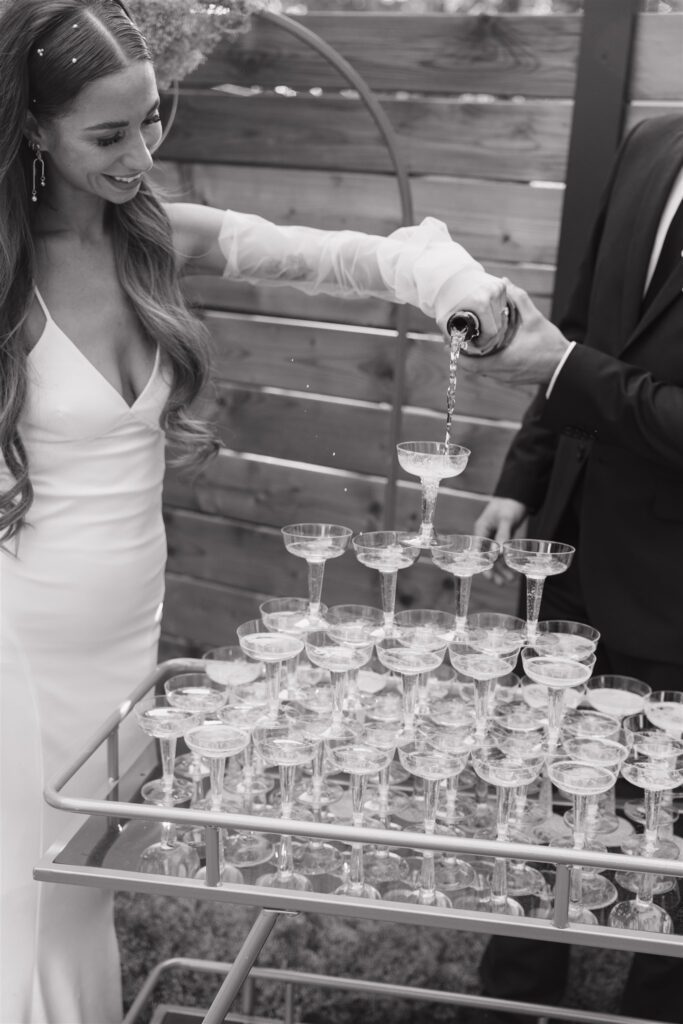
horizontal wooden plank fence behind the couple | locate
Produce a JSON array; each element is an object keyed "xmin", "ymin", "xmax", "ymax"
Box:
[{"xmin": 157, "ymin": 6, "xmax": 683, "ymax": 656}]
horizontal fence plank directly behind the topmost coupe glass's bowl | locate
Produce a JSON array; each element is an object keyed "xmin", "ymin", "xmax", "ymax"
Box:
[{"xmin": 202, "ymin": 385, "xmax": 516, "ymax": 494}]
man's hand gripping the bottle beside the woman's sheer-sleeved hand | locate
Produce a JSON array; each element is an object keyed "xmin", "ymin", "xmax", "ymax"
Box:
[{"xmin": 462, "ymin": 278, "xmax": 569, "ymax": 384}]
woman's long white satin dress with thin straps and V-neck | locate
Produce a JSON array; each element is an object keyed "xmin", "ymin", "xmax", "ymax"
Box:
[{"xmin": 0, "ymin": 295, "xmax": 169, "ymax": 1024}]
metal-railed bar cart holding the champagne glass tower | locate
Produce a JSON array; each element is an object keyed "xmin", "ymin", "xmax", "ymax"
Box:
[{"xmin": 34, "ymin": 658, "xmax": 683, "ymax": 1024}]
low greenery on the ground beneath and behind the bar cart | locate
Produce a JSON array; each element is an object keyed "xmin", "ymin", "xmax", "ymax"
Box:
[{"xmin": 116, "ymin": 893, "xmax": 630, "ymax": 1024}]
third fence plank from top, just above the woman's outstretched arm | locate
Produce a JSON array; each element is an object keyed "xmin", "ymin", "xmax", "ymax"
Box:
[{"xmin": 155, "ymin": 161, "xmax": 563, "ymax": 266}]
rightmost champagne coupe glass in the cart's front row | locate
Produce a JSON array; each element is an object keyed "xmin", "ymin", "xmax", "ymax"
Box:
[{"xmin": 608, "ymin": 732, "xmax": 683, "ymax": 934}]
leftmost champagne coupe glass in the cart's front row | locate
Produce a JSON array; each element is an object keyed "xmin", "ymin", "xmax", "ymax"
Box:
[{"xmin": 135, "ymin": 696, "xmax": 200, "ymax": 878}]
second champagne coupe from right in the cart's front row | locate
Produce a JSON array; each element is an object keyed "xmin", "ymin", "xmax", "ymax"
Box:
[{"xmin": 548, "ymin": 757, "xmax": 616, "ymax": 925}]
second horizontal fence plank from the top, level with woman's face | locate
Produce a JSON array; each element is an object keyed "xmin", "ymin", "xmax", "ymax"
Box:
[{"xmin": 159, "ymin": 90, "xmax": 571, "ymax": 181}]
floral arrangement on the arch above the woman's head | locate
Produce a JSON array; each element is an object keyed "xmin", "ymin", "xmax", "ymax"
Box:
[{"xmin": 126, "ymin": 0, "xmax": 273, "ymax": 89}]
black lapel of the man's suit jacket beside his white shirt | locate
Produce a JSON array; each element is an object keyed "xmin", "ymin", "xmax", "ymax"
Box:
[{"xmin": 617, "ymin": 125, "xmax": 683, "ymax": 354}]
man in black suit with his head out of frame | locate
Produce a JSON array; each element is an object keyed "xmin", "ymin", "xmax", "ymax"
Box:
[{"xmin": 463, "ymin": 115, "xmax": 683, "ymax": 1022}]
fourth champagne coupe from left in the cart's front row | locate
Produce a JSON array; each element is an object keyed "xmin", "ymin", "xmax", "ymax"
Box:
[{"xmin": 325, "ymin": 720, "xmax": 396, "ymax": 899}]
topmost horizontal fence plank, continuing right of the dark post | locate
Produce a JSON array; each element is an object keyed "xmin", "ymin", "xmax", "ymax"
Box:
[{"xmin": 186, "ymin": 12, "xmax": 683, "ymax": 99}]
